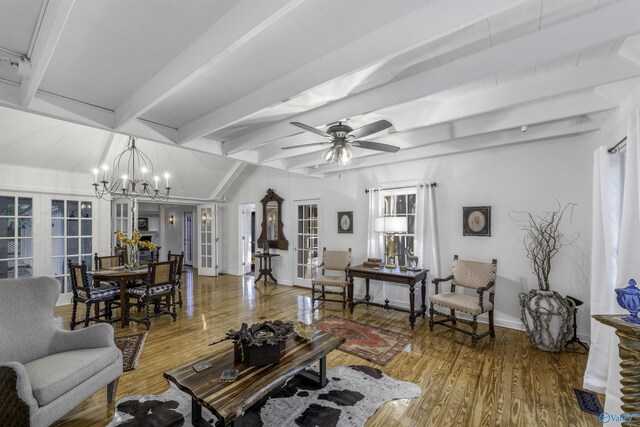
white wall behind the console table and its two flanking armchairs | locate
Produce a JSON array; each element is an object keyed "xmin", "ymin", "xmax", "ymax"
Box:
[{"xmin": 227, "ymin": 132, "xmax": 595, "ymax": 338}]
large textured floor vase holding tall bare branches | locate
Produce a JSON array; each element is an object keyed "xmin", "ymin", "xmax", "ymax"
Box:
[{"xmin": 509, "ymin": 202, "xmax": 578, "ymax": 351}]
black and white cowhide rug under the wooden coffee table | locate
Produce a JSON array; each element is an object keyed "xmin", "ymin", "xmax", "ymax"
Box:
[{"xmin": 107, "ymin": 366, "xmax": 421, "ymax": 427}]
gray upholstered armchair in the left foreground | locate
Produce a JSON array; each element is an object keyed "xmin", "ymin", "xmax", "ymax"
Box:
[{"xmin": 0, "ymin": 277, "xmax": 122, "ymax": 426}]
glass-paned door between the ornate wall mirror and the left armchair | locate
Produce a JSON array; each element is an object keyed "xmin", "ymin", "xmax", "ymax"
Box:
[{"xmin": 294, "ymin": 200, "xmax": 321, "ymax": 286}]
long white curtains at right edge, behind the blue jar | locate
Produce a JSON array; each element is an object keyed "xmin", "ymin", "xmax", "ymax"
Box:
[{"xmin": 584, "ymin": 109, "xmax": 640, "ymax": 425}]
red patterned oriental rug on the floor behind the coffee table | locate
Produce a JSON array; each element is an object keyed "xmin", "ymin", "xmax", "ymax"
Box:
[{"xmin": 313, "ymin": 316, "xmax": 412, "ymax": 366}]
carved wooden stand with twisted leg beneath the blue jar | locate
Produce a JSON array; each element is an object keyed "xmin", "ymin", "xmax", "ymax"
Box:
[{"xmin": 593, "ymin": 314, "xmax": 640, "ymax": 427}]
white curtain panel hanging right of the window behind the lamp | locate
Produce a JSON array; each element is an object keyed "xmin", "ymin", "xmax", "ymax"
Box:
[{"xmin": 413, "ymin": 184, "xmax": 440, "ymax": 277}]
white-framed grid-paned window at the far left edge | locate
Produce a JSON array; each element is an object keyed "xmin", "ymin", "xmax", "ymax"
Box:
[{"xmin": 0, "ymin": 196, "xmax": 33, "ymax": 279}]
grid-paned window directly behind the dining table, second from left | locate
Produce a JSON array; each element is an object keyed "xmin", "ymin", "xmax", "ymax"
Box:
[{"xmin": 51, "ymin": 200, "xmax": 93, "ymax": 293}]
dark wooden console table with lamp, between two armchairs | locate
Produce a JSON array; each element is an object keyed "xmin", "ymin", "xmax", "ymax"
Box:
[{"xmin": 347, "ymin": 265, "xmax": 429, "ymax": 329}]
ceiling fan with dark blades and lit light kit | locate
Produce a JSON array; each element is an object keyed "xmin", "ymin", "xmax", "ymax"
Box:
[{"xmin": 282, "ymin": 120, "xmax": 400, "ymax": 164}]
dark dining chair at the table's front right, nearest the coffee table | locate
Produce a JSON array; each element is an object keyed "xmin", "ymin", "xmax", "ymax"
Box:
[{"xmin": 125, "ymin": 261, "xmax": 177, "ymax": 329}]
